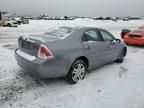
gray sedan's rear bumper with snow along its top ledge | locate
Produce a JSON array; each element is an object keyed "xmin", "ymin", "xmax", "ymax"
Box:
[{"xmin": 15, "ymin": 49, "xmax": 68, "ymax": 78}]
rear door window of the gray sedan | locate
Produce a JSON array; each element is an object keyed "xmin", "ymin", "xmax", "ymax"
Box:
[{"xmin": 82, "ymin": 30, "xmax": 100, "ymax": 41}]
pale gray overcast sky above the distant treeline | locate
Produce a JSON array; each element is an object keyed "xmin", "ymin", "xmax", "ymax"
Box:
[{"xmin": 0, "ymin": 0, "xmax": 144, "ymax": 16}]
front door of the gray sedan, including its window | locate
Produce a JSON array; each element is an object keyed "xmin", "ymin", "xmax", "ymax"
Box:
[{"xmin": 99, "ymin": 30, "xmax": 120, "ymax": 62}]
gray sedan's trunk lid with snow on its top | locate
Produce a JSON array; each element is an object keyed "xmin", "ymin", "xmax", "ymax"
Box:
[{"xmin": 18, "ymin": 35, "xmax": 59, "ymax": 57}]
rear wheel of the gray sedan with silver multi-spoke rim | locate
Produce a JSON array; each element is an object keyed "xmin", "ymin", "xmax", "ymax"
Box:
[{"xmin": 66, "ymin": 60, "xmax": 87, "ymax": 84}]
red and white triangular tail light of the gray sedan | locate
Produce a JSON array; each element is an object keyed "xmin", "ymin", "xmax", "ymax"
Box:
[{"xmin": 38, "ymin": 45, "xmax": 53, "ymax": 59}]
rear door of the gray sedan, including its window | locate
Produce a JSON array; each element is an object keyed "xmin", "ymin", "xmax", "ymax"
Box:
[{"xmin": 82, "ymin": 29, "xmax": 106, "ymax": 68}]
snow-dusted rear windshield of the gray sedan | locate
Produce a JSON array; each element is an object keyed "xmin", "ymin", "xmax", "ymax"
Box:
[{"xmin": 44, "ymin": 27, "xmax": 76, "ymax": 37}]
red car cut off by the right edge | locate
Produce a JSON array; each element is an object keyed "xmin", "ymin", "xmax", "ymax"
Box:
[{"xmin": 121, "ymin": 29, "xmax": 144, "ymax": 45}]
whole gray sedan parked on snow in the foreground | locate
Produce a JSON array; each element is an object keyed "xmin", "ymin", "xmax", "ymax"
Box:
[{"xmin": 15, "ymin": 27, "xmax": 127, "ymax": 84}]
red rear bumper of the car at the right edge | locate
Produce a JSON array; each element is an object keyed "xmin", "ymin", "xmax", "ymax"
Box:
[{"xmin": 124, "ymin": 37, "xmax": 144, "ymax": 45}]
